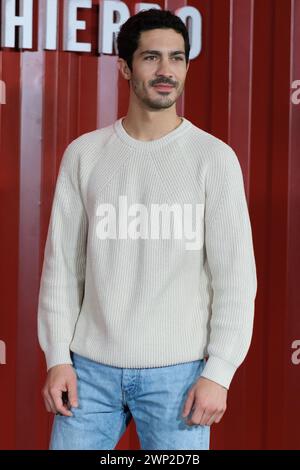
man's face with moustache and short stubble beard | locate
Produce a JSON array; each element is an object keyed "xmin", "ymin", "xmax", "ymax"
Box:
[{"xmin": 124, "ymin": 29, "xmax": 188, "ymax": 109}]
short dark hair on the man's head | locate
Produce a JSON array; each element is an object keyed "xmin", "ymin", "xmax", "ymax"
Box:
[{"xmin": 117, "ymin": 8, "xmax": 190, "ymax": 71}]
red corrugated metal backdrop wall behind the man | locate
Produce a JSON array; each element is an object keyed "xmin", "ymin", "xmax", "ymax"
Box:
[{"xmin": 0, "ymin": 0, "xmax": 300, "ymax": 449}]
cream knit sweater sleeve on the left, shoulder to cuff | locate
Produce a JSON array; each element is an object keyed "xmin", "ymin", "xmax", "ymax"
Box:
[{"xmin": 38, "ymin": 142, "xmax": 88, "ymax": 370}]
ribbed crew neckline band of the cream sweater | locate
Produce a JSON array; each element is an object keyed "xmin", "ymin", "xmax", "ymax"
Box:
[{"xmin": 114, "ymin": 116, "xmax": 192, "ymax": 150}]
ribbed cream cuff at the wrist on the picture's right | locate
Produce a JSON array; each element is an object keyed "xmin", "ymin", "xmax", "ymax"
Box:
[{"xmin": 201, "ymin": 356, "xmax": 237, "ymax": 390}]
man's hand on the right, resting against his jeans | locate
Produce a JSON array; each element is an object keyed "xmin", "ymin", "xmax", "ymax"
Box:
[{"xmin": 182, "ymin": 377, "xmax": 228, "ymax": 426}]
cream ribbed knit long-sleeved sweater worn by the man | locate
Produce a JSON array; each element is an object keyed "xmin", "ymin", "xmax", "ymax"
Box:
[{"xmin": 38, "ymin": 118, "xmax": 257, "ymax": 388}]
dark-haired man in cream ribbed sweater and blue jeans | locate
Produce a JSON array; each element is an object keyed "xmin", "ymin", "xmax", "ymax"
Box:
[{"xmin": 38, "ymin": 9, "xmax": 257, "ymax": 449}]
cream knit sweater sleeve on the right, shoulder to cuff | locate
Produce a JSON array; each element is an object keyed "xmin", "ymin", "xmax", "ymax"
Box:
[{"xmin": 201, "ymin": 144, "xmax": 257, "ymax": 389}]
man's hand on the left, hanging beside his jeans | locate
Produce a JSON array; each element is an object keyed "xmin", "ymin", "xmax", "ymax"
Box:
[{"xmin": 42, "ymin": 364, "xmax": 78, "ymax": 416}]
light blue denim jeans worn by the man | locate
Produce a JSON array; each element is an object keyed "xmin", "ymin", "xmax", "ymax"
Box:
[{"xmin": 50, "ymin": 353, "xmax": 210, "ymax": 450}]
